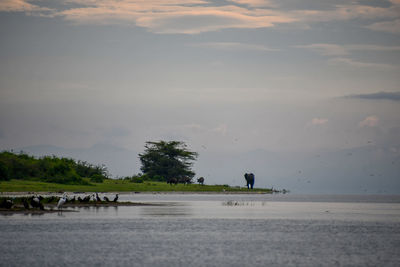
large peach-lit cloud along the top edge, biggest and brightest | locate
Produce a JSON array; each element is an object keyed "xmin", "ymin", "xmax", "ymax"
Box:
[{"xmin": 59, "ymin": 0, "xmax": 293, "ymax": 34}]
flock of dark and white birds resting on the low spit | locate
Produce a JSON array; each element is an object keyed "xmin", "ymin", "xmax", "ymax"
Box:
[{"xmin": 0, "ymin": 193, "xmax": 118, "ymax": 213}]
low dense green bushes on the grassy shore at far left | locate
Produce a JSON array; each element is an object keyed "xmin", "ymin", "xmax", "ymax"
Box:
[{"xmin": 0, "ymin": 151, "xmax": 108, "ymax": 185}]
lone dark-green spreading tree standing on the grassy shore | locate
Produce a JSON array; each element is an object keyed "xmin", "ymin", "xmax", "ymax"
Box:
[{"xmin": 139, "ymin": 141, "xmax": 198, "ymax": 183}]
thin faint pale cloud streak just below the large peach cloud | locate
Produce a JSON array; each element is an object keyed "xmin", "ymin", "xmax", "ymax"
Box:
[{"xmin": 190, "ymin": 42, "xmax": 280, "ymax": 52}]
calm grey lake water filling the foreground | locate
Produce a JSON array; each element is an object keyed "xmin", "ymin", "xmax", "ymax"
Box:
[{"xmin": 0, "ymin": 194, "xmax": 400, "ymax": 266}]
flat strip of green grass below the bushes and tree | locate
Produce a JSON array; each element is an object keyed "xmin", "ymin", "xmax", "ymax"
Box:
[{"xmin": 0, "ymin": 179, "xmax": 271, "ymax": 193}]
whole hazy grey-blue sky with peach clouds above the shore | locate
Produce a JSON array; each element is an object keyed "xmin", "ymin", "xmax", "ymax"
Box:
[{"xmin": 0, "ymin": 0, "xmax": 400, "ymax": 194}]
